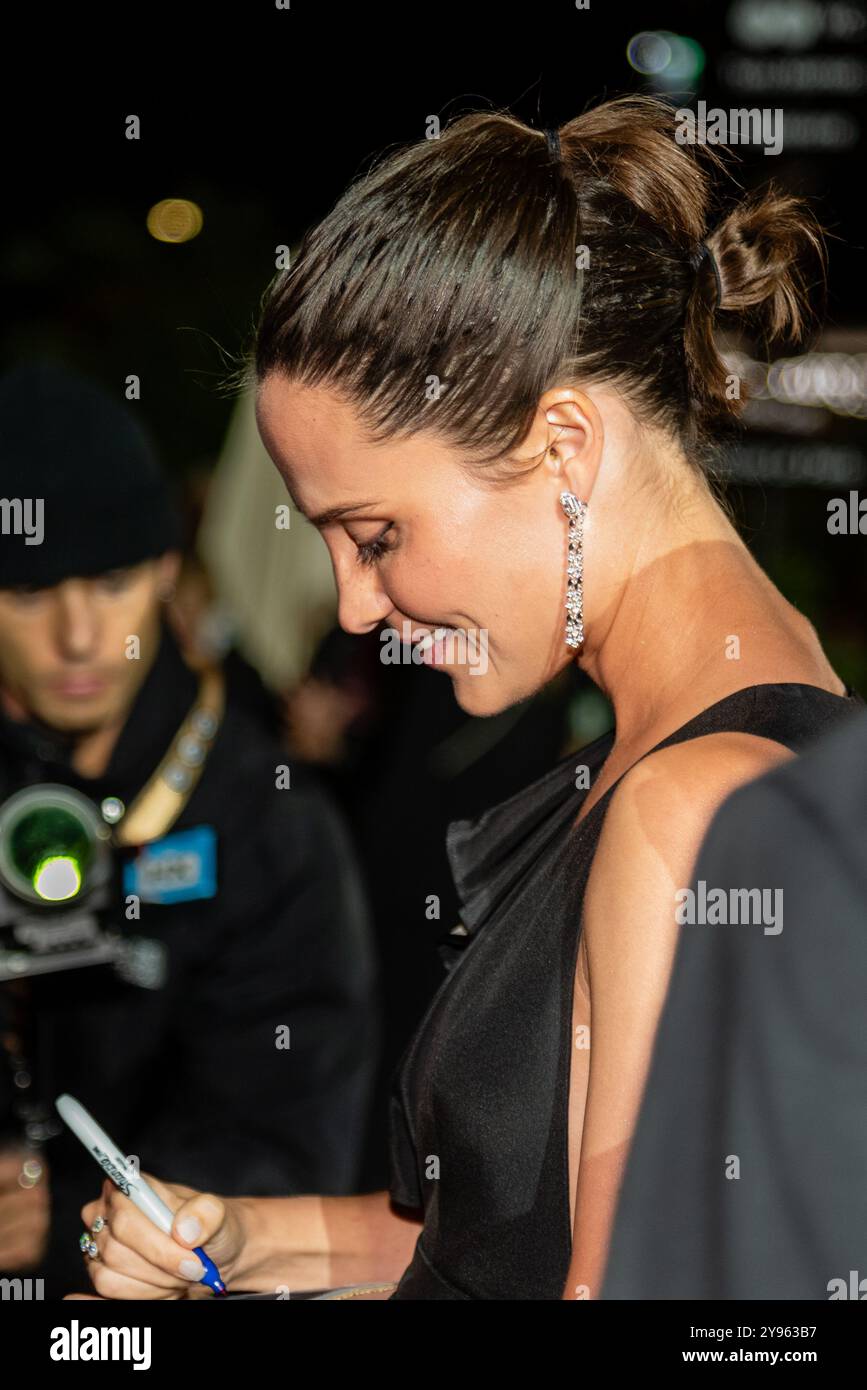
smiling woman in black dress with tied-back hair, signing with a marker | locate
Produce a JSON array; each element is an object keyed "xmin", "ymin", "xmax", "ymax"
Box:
[{"xmin": 72, "ymin": 96, "xmax": 859, "ymax": 1300}]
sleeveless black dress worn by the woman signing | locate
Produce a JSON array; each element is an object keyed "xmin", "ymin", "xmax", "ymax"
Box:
[{"xmin": 389, "ymin": 682, "xmax": 863, "ymax": 1300}]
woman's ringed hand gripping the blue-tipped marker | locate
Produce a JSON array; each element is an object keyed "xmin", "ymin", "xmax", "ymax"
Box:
[{"xmin": 67, "ymin": 1173, "xmax": 246, "ymax": 1298}]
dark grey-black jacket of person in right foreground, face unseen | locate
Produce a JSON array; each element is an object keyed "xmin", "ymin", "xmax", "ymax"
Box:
[{"xmin": 602, "ymin": 709, "xmax": 867, "ymax": 1301}]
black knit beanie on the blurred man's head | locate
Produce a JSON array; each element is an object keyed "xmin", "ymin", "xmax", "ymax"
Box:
[{"xmin": 0, "ymin": 359, "xmax": 181, "ymax": 588}]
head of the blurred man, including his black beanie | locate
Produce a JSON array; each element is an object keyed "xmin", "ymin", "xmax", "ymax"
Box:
[{"xmin": 0, "ymin": 363, "xmax": 179, "ymax": 745}]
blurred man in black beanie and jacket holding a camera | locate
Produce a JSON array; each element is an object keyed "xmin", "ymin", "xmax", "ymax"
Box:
[{"xmin": 0, "ymin": 361, "xmax": 379, "ymax": 1298}]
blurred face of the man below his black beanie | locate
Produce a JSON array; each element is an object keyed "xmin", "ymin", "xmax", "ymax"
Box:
[{"xmin": 0, "ymin": 555, "xmax": 176, "ymax": 734}]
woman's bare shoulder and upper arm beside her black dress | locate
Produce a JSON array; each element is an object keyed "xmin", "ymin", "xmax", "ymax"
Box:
[{"xmin": 565, "ymin": 734, "xmax": 792, "ymax": 1297}]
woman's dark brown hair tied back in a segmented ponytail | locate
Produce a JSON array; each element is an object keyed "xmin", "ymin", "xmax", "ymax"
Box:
[{"xmin": 244, "ymin": 96, "xmax": 825, "ymax": 483}]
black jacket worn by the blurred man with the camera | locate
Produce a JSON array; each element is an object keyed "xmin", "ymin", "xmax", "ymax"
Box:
[{"xmin": 0, "ymin": 630, "xmax": 381, "ymax": 1297}]
